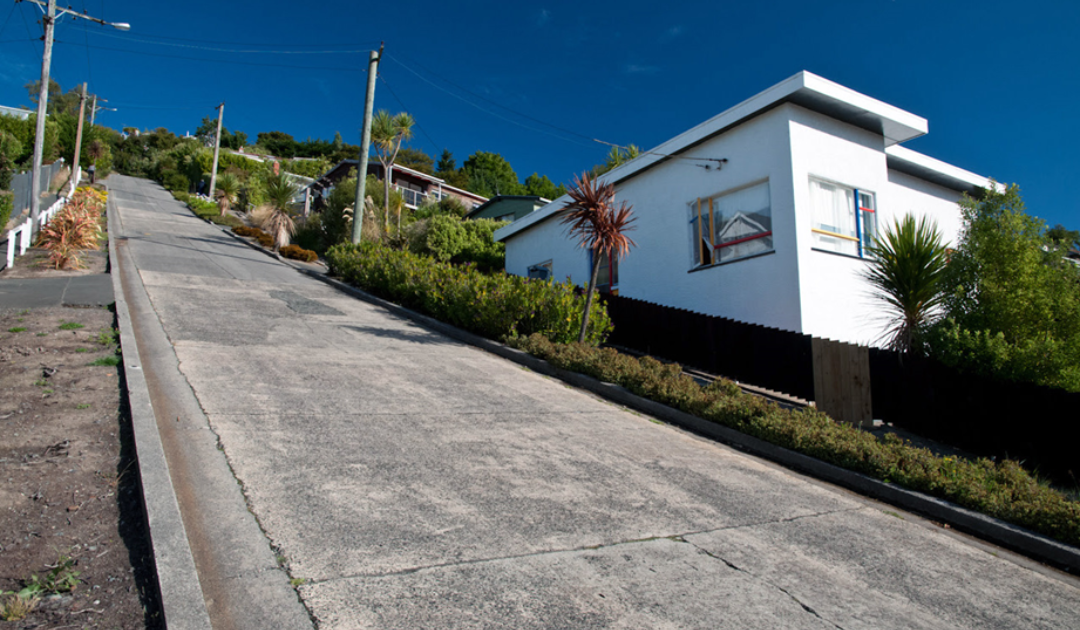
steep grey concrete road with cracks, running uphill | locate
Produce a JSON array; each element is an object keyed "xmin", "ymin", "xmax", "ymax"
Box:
[{"xmin": 110, "ymin": 176, "xmax": 1080, "ymax": 630}]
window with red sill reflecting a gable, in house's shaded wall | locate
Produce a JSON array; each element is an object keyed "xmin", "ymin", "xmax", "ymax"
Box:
[{"xmin": 690, "ymin": 182, "xmax": 772, "ymax": 267}]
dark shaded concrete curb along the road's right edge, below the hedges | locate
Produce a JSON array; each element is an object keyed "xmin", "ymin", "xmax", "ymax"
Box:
[{"xmin": 280, "ymin": 264, "xmax": 1080, "ymax": 574}]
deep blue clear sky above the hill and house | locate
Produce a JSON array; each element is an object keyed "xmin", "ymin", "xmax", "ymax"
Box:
[{"xmin": 0, "ymin": 0, "xmax": 1080, "ymax": 229}]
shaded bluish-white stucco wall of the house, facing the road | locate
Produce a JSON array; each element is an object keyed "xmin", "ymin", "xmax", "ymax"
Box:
[{"xmin": 507, "ymin": 106, "xmax": 799, "ymax": 330}]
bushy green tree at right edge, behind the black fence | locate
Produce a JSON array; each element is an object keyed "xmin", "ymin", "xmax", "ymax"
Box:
[{"xmin": 928, "ymin": 186, "xmax": 1080, "ymax": 391}]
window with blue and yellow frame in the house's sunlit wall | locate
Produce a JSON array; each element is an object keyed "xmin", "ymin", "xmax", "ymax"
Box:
[{"xmin": 810, "ymin": 179, "xmax": 877, "ymax": 257}]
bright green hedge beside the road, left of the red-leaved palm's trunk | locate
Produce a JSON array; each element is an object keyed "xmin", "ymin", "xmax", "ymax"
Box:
[{"xmin": 326, "ymin": 243, "xmax": 611, "ymax": 345}]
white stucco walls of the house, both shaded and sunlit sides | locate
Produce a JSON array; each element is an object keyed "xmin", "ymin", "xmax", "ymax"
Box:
[{"xmin": 505, "ymin": 104, "xmax": 976, "ymax": 344}]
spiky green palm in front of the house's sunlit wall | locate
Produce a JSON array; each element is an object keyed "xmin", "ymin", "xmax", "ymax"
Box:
[{"xmin": 865, "ymin": 215, "xmax": 948, "ymax": 352}]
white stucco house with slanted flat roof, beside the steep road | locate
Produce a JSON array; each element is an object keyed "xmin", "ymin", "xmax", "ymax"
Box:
[{"xmin": 495, "ymin": 71, "xmax": 988, "ymax": 344}]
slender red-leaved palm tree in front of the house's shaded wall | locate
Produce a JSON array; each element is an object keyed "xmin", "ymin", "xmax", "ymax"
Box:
[{"xmin": 563, "ymin": 173, "xmax": 637, "ymax": 344}]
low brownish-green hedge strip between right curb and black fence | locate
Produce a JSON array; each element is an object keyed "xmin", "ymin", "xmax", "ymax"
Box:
[{"xmin": 508, "ymin": 335, "xmax": 1080, "ymax": 546}]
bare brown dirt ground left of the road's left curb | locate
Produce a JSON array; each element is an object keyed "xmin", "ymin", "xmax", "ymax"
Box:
[{"xmin": 0, "ymin": 304, "xmax": 162, "ymax": 630}]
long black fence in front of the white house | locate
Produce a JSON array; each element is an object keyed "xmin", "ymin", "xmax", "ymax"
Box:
[{"xmin": 605, "ymin": 296, "xmax": 1080, "ymax": 485}]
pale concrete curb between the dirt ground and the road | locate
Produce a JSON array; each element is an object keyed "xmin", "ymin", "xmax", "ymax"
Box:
[{"xmin": 108, "ymin": 194, "xmax": 212, "ymax": 630}]
